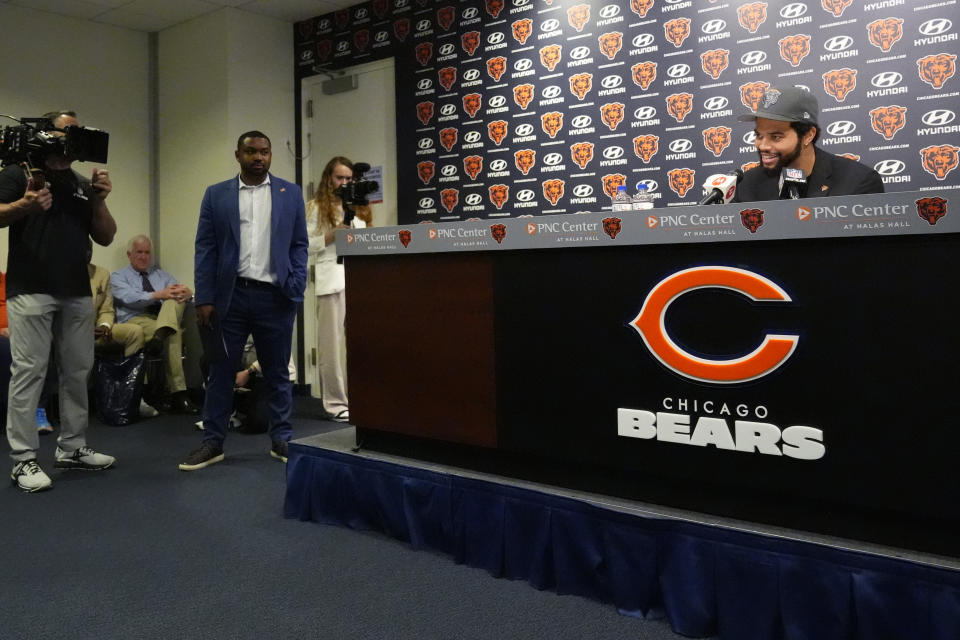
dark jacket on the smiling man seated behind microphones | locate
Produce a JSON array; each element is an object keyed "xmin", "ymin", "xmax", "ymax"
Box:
[{"xmin": 733, "ymin": 147, "xmax": 883, "ymax": 202}]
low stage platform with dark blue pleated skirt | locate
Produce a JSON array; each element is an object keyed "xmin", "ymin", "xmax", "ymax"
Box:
[{"xmin": 284, "ymin": 427, "xmax": 960, "ymax": 640}]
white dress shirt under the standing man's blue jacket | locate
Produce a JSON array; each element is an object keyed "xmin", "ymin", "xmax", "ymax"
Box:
[{"xmin": 237, "ymin": 174, "xmax": 277, "ymax": 284}]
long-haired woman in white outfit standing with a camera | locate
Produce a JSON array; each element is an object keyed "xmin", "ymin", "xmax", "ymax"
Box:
[{"xmin": 307, "ymin": 156, "xmax": 373, "ymax": 422}]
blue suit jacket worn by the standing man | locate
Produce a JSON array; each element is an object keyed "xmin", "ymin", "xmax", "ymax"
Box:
[{"xmin": 194, "ymin": 174, "xmax": 309, "ymax": 317}]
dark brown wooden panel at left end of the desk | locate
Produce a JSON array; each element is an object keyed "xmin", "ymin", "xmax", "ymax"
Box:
[{"xmin": 345, "ymin": 253, "xmax": 497, "ymax": 447}]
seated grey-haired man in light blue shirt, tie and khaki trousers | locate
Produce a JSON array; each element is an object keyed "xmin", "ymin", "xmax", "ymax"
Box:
[{"xmin": 110, "ymin": 235, "xmax": 198, "ymax": 413}]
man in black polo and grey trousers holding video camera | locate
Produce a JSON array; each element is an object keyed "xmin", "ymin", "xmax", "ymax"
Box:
[{"xmin": 0, "ymin": 111, "xmax": 117, "ymax": 492}]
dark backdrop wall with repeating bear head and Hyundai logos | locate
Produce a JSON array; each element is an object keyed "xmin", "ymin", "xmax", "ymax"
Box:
[{"xmin": 295, "ymin": 0, "xmax": 960, "ymax": 224}]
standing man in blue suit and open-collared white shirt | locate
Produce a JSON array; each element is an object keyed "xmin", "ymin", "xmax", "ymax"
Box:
[{"xmin": 180, "ymin": 131, "xmax": 308, "ymax": 471}]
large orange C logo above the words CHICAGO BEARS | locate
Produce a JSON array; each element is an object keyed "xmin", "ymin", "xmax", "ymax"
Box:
[{"xmin": 630, "ymin": 266, "xmax": 800, "ymax": 384}]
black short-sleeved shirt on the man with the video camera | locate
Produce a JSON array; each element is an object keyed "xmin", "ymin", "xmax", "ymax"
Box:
[{"xmin": 0, "ymin": 165, "xmax": 93, "ymax": 298}]
